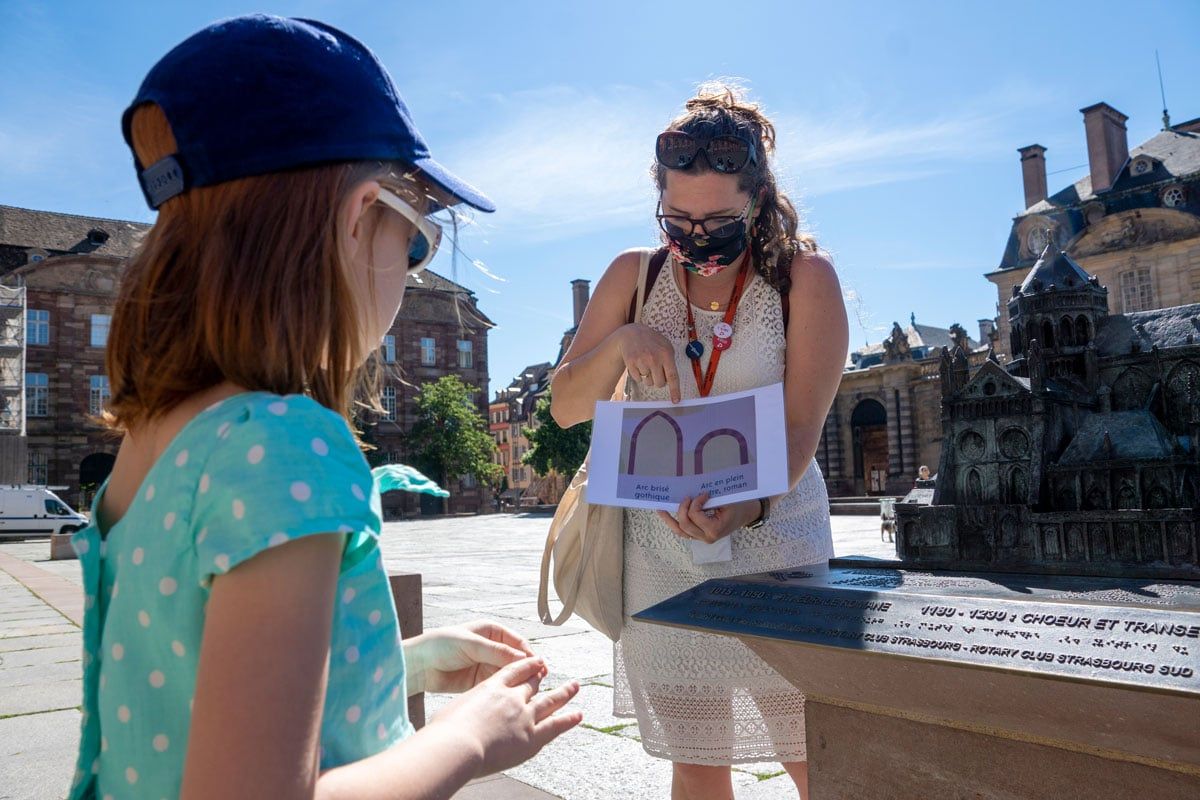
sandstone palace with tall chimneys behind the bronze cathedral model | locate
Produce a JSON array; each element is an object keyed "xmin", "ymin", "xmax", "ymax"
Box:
[{"xmin": 817, "ymin": 103, "xmax": 1200, "ymax": 495}]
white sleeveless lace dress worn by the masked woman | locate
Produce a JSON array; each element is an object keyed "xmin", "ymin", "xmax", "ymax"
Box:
[{"xmin": 613, "ymin": 260, "xmax": 833, "ymax": 765}]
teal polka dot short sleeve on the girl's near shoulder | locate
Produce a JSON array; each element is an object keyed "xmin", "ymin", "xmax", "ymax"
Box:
[{"xmin": 192, "ymin": 395, "xmax": 379, "ymax": 583}]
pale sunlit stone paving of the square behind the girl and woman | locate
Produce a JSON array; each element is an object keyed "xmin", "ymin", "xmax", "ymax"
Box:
[{"xmin": 0, "ymin": 515, "xmax": 894, "ymax": 800}]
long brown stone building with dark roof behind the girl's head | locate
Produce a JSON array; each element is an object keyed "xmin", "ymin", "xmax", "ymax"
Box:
[{"xmin": 0, "ymin": 206, "xmax": 492, "ymax": 516}]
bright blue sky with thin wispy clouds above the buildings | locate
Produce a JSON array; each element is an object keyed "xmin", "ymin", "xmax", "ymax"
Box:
[{"xmin": 0, "ymin": 0, "xmax": 1200, "ymax": 391}]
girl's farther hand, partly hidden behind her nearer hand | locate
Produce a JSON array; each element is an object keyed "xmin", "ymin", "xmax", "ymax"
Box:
[{"xmin": 404, "ymin": 620, "xmax": 533, "ymax": 694}]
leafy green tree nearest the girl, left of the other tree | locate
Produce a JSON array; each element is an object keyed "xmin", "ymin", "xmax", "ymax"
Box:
[{"xmin": 407, "ymin": 375, "xmax": 504, "ymax": 507}]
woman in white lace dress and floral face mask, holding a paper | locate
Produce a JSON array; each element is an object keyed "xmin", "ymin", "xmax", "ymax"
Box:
[{"xmin": 552, "ymin": 86, "xmax": 848, "ymax": 800}]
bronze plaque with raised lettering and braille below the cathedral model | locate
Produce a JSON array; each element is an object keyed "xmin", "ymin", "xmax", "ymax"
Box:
[{"xmin": 634, "ymin": 566, "xmax": 1200, "ymax": 694}]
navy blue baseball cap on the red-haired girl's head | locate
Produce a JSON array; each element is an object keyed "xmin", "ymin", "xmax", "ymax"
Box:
[{"xmin": 121, "ymin": 14, "xmax": 496, "ymax": 211}]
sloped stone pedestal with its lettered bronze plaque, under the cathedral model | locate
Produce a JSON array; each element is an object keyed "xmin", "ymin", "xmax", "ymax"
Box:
[{"xmin": 636, "ymin": 567, "xmax": 1200, "ymax": 800}]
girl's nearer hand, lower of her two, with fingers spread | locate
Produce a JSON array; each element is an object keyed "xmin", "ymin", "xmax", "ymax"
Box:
[{"xmin": 426, "ymin": 657, "xmax": 583, "ymax": 777}]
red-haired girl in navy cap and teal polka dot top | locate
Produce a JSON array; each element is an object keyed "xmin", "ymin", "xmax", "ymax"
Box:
[{"xmin": 72, "ymin": 16, "xmax": 580, "ymax": 799}]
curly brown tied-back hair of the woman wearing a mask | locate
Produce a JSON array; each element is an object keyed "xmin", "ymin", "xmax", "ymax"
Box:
[{"xmin": 653, "ymin": 83, "xmax": 818, "ymax": 294}]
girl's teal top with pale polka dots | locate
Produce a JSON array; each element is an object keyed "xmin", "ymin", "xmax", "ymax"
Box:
[{"xmin": 71, "ymin": 392, "xmax": 412, "ymax": 800}]
